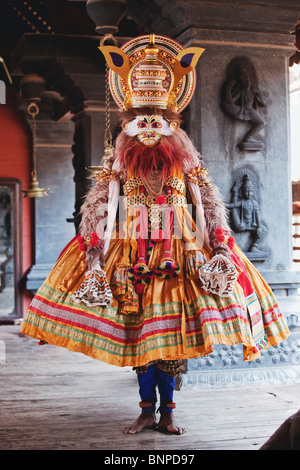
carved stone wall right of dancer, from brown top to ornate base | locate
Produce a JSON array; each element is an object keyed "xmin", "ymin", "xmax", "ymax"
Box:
[{"xmin": 170, "ymin": 1, "xmax": 300, "ymax": 388}]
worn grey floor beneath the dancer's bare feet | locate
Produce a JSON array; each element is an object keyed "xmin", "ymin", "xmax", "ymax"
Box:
[{"xmin": 0, "ymin": 325, "xmax": 300, "ymax": 456}]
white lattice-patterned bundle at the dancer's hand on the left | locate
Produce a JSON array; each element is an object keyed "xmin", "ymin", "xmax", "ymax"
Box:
[{"xmin": 71, "ymin": 269, "xmax": 112, "ymax": 307}]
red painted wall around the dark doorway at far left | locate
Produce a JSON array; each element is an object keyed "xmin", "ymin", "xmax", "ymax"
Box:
[{"xmin": 0, "ymin": 88, "xmax": 34, "ymax": 317}]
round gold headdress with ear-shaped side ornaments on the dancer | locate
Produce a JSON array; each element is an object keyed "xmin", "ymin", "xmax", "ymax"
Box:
[{"xmin": 99, "ymin": 34, "xmax": 204, "ymax": 112}]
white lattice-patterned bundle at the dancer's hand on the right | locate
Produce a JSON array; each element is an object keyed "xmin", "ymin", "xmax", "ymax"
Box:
[{"xmin": 199, "ymin": 255, "xmax": 238, "ymax": 297}]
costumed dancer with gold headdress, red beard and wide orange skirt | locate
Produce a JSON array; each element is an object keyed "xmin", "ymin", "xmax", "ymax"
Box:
[{"xmin": 21, "ymin": 35, "xmax": 289, "ymax": 434}]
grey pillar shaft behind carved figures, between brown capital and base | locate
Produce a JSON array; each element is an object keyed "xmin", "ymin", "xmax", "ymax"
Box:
[{"xmin": 179, "ymin": 26, "xmax": 300, "ymax": 295}]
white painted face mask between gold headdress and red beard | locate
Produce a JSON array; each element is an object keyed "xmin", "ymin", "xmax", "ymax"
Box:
[{"xmin": 124, "ymin": 115, "xmax": 179, "ymax": 147}]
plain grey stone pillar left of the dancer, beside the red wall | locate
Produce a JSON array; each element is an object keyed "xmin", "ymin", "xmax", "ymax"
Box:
[{"xmin": 26, "ymin": 96, "xmax": 75, "ymax": 293}]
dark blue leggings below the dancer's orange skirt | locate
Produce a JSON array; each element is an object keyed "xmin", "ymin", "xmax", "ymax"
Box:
[{"xmin": 137, "ymin": 364, "xmax": 175, "ymax": 413}]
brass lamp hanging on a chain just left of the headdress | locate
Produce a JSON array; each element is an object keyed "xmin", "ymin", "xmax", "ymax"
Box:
[{"xmin": 87, "ymin": 34, "xmax": 117, "ymax": 178}]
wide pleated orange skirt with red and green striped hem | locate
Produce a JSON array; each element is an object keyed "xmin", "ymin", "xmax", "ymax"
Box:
[{"xmin": 21, "ymin": 235, "xmax": 289, "ymax": 367}]
